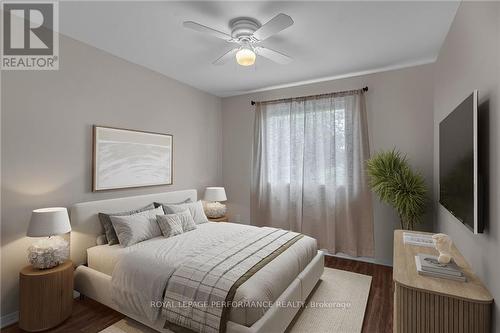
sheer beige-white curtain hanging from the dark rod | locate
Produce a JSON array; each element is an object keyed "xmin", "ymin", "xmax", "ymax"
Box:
[{"xmin": 251, "ymin": 90, "xmax": 374, "ymax": 256}]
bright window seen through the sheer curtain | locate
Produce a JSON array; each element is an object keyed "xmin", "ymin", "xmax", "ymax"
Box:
[{"xmin": 264, "ymin": 99, "xmax": 347, "ymax": 185}]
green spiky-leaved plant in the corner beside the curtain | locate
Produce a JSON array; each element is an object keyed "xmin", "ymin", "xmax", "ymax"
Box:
[{"xmin": 367, "ymin": 149, "xmax": 427, "ymax": 230}]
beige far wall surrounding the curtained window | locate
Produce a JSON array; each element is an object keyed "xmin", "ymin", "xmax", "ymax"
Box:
[{"xmin": 222, "ymin": 65, "xmax": 433, "ymax": 264}]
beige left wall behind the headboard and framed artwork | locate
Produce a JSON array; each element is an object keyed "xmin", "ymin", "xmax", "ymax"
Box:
[{"xmin": 1, "ymin": 37, "xmax": 222, "ymax": 316}]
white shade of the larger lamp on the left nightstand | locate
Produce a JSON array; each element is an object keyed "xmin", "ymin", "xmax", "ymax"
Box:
[{"xmin": 26, "ymin": 207, "xmax": 71, "ymax": 237}]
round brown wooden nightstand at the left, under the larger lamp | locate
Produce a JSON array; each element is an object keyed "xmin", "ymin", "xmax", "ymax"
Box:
[{"xmin": 19, "ymin": 260, "xmax": 73, "ymax": 332}]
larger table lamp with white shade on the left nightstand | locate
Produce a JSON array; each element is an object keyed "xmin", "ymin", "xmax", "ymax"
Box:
[{"xmin": 26, "ymin": 207, "xmax": 71, "ymax": 269}]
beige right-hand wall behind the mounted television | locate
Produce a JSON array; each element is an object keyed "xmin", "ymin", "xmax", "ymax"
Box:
[{"xmin": 434, "ymin": 2, "xmax": 500, "ymax": 332}]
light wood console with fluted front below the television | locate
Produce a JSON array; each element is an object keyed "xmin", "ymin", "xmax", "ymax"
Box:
[{"xmin": 393, "ymin": 230, "xmax": 493, "ymax": 333}]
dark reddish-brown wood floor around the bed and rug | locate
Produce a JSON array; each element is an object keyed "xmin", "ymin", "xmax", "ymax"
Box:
[{"xmin": 2, "ymin": 256, "xmax": 393, "ymax": 333}]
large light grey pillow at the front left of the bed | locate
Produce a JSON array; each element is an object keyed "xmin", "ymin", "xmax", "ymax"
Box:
[{"xmin": 110, "ymin": 207, "xmax": 163, "ymax": 247}]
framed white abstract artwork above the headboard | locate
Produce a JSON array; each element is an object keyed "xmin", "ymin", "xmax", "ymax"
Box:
[{"xmin": 93, "ymin": 126, "xmax": 173, "ymax": 191}]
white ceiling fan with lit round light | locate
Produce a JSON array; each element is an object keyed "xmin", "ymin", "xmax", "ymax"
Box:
[{"xmin": 183, "ymin": 14, "xmax": 293, "ymax": 66}]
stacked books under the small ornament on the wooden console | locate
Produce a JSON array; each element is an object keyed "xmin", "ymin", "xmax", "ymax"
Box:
[{"xmin": 415, "ymin": 253, "xmax": 467, "ymax": 281}]
